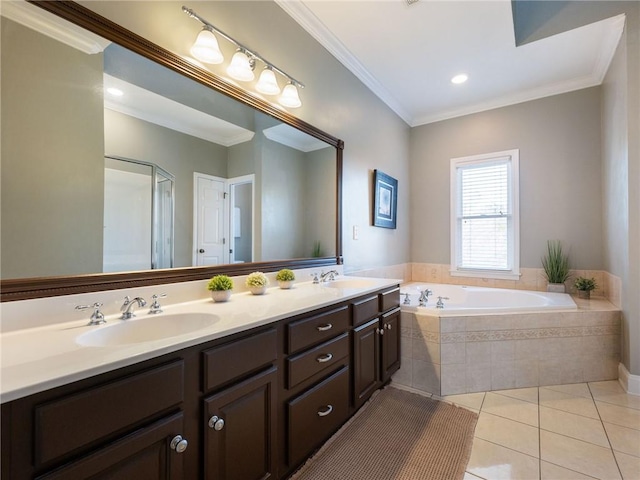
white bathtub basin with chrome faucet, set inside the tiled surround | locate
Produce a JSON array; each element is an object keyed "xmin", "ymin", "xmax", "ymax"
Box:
[{"xmin": 400, "ymin": 283, "xmax": 578, "ymax": 316}]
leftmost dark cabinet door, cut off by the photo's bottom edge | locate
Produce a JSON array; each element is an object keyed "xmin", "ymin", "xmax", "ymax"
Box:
[{"xmin": 37, "ymin": 412, "xmax": 186, "ymax": 480}]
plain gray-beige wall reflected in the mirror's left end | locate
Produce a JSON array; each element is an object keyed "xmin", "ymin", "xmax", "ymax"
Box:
[{"xmin": 0, "ymin": 17, "xmax": 104, "ymax": 278}]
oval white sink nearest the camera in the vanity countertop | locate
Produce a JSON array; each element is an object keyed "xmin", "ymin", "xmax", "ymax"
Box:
[{"xmin": 76, "ymin": 313, "xmax": 220, "ymax": 347}]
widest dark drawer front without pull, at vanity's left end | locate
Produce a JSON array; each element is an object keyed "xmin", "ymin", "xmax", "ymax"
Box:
[{"xmin": 34, "ymin": 360, "xmax": 184, "ymax": 465}]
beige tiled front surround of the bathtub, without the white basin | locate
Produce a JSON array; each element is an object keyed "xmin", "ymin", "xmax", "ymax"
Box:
[{"xmin": 394, "ymin": 306, "xmax": 620, "ymax": 395}]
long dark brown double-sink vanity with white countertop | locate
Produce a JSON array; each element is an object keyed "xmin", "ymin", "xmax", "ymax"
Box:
[{"xmin": 2, "ymin": 277, "xmax": 400, "ymax": 480}]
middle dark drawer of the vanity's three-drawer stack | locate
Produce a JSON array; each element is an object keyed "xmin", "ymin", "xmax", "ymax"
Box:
[{"xmin": 287, "ymin": 333, "xmax": 349, "ymax": 389}]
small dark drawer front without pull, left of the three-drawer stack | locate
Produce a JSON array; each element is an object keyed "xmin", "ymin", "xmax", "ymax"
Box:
[{"xmin": 202, "ymin": 328, "xmax": 277, "ymax": 392}]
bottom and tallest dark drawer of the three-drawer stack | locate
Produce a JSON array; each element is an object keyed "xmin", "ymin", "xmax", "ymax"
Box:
[{"xmin": 287, "ymin": 367, "xmax": 349, "ymax": 465}]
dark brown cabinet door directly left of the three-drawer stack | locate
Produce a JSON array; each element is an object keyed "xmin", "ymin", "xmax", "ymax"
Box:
[{"xmin": 204, "ymin": 367, "xmax": 277, "ymax": 480}]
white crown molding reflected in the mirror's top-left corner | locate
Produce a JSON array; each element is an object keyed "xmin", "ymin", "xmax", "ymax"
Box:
[{"xmin": 0, "ymin": 1, "xmax": 111, "ymax": 55}]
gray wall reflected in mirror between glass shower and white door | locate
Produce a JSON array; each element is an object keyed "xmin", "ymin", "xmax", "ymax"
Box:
[{"xmin": 107, "ymin": 109, "xmax": 228, "ymax": 271}]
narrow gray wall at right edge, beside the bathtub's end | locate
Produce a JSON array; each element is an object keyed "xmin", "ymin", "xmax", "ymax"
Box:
[{"xmin": 602, "ymin": 3, "xmax": 640, "ymax": 375}]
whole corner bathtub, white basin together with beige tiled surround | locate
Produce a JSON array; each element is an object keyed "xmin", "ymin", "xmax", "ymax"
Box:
[{"xmin": 392, "ymin": 282, "xmax": 621, "ymax": 396}]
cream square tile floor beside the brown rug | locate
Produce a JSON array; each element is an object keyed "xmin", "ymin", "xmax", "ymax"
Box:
[{"xmin": 396, "ymin": 381, "xmax": 640, "ymax": 480}]
